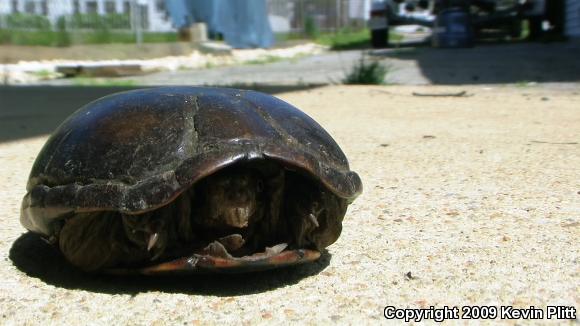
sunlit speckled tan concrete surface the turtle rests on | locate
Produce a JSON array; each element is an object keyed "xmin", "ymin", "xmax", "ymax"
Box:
[{"xmin": 0, "ymin": 86, "xmax": 580, "ymax": 325}]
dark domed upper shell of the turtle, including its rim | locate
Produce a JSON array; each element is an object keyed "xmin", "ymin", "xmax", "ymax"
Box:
[{"xmin": 21, "ymin": 87, "xmax": 362, "ymax": 272}]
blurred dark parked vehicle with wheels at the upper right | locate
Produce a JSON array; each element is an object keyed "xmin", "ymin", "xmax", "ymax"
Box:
[{"xmin": 369, "ymin": 0, "xmax": 562, "ymax": 48}]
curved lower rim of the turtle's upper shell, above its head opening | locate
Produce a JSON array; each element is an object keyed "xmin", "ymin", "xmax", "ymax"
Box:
[{"xmin": 20, "ymin": 143, "xmax": 362, "ymax": 236}]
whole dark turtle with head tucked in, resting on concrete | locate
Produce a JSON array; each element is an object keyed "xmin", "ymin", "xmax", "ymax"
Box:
[{"xmin": 20, "ymin": 86, "xmax": 362, "ymax": 275}]
